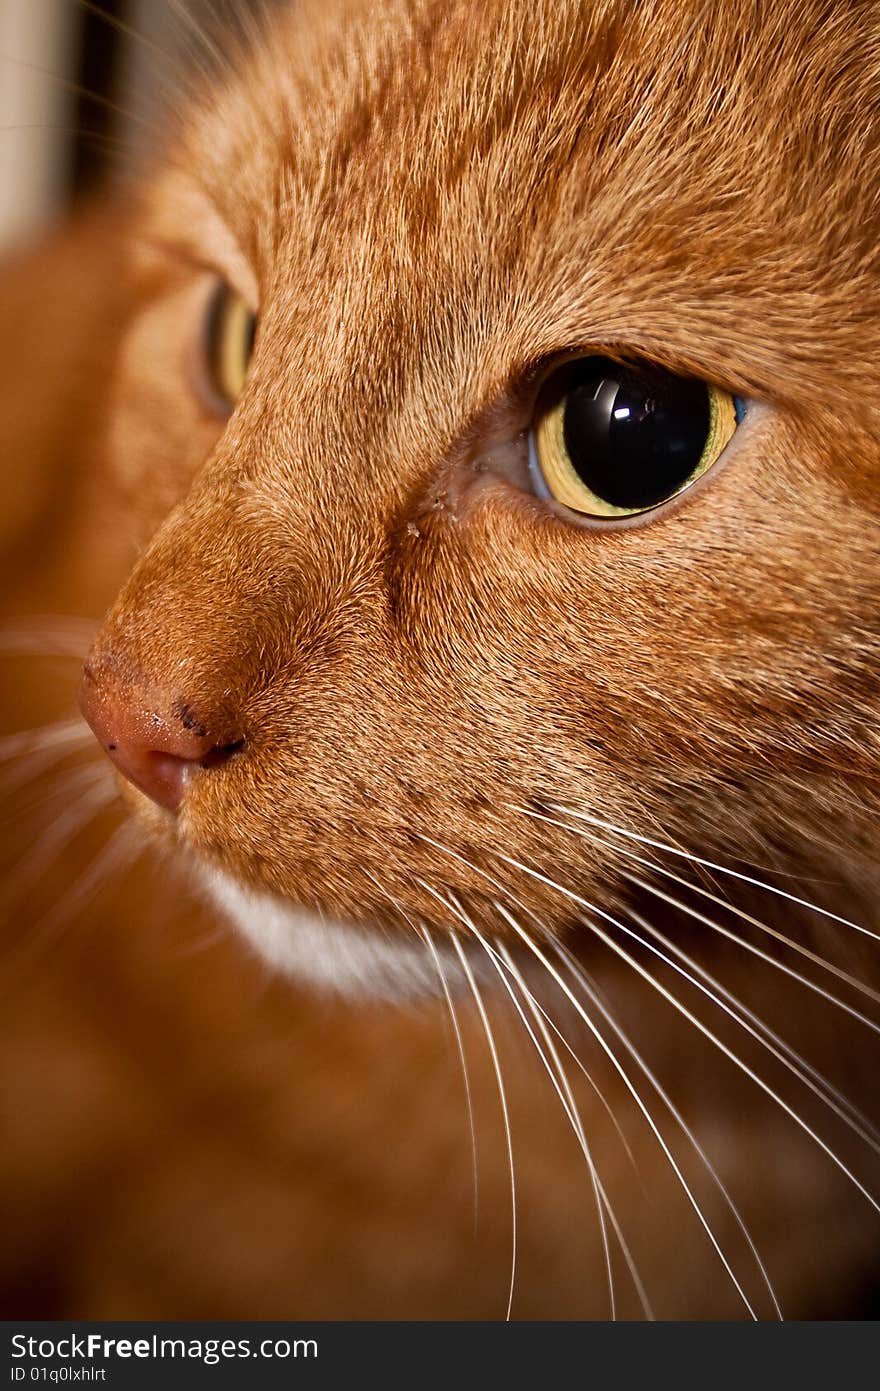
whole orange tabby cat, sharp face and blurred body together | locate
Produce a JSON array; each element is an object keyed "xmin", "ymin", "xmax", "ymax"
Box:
[{"xmin": 4, "ymin": 0, "xmax": 880, "ymax": 1319}]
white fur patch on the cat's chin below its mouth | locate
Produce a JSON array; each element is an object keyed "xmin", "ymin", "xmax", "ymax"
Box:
[{"xmin": 199, "ymin": 865, "xmax": 457, "ymax": 1000}]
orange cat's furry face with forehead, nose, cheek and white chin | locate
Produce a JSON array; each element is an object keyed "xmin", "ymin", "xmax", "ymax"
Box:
[{"xmin": 78, "ymin": 0, "xmax": 880, "ymax": 989}]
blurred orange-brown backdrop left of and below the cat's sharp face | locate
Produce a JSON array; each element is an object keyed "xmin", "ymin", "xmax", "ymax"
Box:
[{"xmin": 0, "ymin": 0, "xmax": 877, "ymax": 1319}]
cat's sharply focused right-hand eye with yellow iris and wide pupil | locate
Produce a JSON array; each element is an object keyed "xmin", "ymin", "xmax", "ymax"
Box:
[{"xmin": 528, "ymin": 357, "xmax": 745, "ymax": 519}]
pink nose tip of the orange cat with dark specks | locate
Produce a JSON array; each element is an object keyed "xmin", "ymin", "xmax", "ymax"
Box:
[{"xmin": 79, "ymin": 665, "xmax": 243, "ymax": 811}]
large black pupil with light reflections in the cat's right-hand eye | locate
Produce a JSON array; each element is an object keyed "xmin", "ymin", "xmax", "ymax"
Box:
[{"xmin": 553, "ymin": 357, "xmax": 710, "ymax": 508}]
